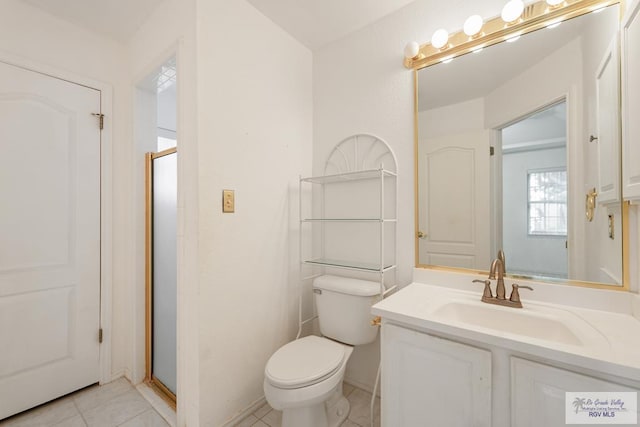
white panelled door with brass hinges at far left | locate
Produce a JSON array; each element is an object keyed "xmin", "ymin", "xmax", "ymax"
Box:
[{"xmin": 0, "ymin": 63, "xmax": 100, "ymax": 419}]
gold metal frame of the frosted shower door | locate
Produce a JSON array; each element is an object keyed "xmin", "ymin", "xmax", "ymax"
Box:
[{"xmin": 144, "ymin": 147, "xmax": 178, "ymax": 410}]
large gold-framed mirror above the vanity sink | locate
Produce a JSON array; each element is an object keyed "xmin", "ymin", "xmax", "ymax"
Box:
[{"xmin": 414, "ymin": 2, "xmax": 626, "ymax": 288}]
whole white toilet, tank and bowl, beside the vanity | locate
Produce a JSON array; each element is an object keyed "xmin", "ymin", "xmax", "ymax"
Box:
[{"xmin": 264, "ymin": 275, "xmax": 380, "ymax": 427}]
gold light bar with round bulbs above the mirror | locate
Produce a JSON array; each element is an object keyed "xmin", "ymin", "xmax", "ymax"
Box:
[{"xmin": 404, "ymin": 0, "xmax": 621, "ymax": 70}]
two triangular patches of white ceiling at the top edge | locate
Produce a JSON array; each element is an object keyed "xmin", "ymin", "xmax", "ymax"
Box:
[{"xmin": 22, "ymin": 0, "xmax": 414, "ymax": 50}]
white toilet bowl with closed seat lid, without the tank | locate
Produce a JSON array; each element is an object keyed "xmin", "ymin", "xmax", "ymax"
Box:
[{"xmin": 264, "ymin": 335, "xmax": 353, "ymax": 427}]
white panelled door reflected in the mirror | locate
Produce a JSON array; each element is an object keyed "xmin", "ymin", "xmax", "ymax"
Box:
[{"xmin": 419, "ymin": 130, "xmax": 491, "ymax": 269}]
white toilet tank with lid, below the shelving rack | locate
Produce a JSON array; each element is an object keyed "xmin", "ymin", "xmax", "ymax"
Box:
[{"xmin": 313, "ymin": 275, "xmax": 380, "ymax": 345}]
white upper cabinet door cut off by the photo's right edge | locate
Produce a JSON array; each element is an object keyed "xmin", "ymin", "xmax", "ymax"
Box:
[{"xmin": 621, "ymin": 0, "xmax": 640, "ymax": 200}]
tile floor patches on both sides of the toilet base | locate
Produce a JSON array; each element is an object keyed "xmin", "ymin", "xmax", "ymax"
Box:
[{"xmin": 236, "ymin": 383, "xmax": 380, "ymax": 427}]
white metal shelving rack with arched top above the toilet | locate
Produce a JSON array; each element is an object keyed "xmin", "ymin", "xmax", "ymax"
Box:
[{"xmin": 299, "ymin": 135, "xmax": 397, "ymax": 297}]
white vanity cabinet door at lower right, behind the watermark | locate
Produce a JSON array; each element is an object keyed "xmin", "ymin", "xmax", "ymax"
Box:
[{"xmin": 511, "ymin": 357, "xmax": 638, "ymax": 427}]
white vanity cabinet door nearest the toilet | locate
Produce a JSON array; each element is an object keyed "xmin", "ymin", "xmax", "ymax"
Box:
[{"xmin": 382, "ymin": 324, "xmax": 491, "ymax": 427}]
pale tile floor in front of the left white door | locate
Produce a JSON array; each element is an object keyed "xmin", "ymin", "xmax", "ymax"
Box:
[{"xmin": 0, "ymin": 378, "xmax": 169, "ymax": 427}]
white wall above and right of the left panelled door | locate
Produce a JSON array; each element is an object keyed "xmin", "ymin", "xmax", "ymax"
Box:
[{"xmin": 0, "ymin": 0, "xmax": 130, "ymax": 384}]
